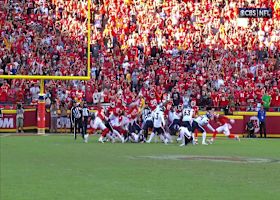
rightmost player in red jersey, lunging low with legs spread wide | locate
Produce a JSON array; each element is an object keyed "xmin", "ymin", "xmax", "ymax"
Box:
[{"xmin": 208, "ymin": 114, "xmax": 240, "ymax": 144}]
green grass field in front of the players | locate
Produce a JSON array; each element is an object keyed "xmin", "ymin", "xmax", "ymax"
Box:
[{"xmin": 0, "ymin": 136, "xmax": 280, "ymax": 200}]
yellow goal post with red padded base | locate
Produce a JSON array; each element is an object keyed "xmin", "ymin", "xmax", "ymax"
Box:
[{"xmin": 0, "ymin": 0, "xmax": 91, "ymax": 134}]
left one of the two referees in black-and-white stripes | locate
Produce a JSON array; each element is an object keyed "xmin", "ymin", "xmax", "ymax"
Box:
[{"xmin": 71, "ymin": 102, "xmax": 84, "ymax": 140}]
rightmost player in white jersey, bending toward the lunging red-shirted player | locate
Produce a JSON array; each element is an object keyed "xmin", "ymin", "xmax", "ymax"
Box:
[{"xmin": 192, "ymin": 114, "xmax": 215, "ymax": 145}]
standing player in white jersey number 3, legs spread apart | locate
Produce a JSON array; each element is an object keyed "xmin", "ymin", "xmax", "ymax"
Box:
[{"xmin": 147, "ymin": 106, "xmax": 168, "ymax": 144}]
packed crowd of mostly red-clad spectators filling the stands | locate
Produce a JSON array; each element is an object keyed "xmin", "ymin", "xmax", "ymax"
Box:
[{"xmin": 0, "ymin": 0, "xmax": 280, "ymax": 110}]
